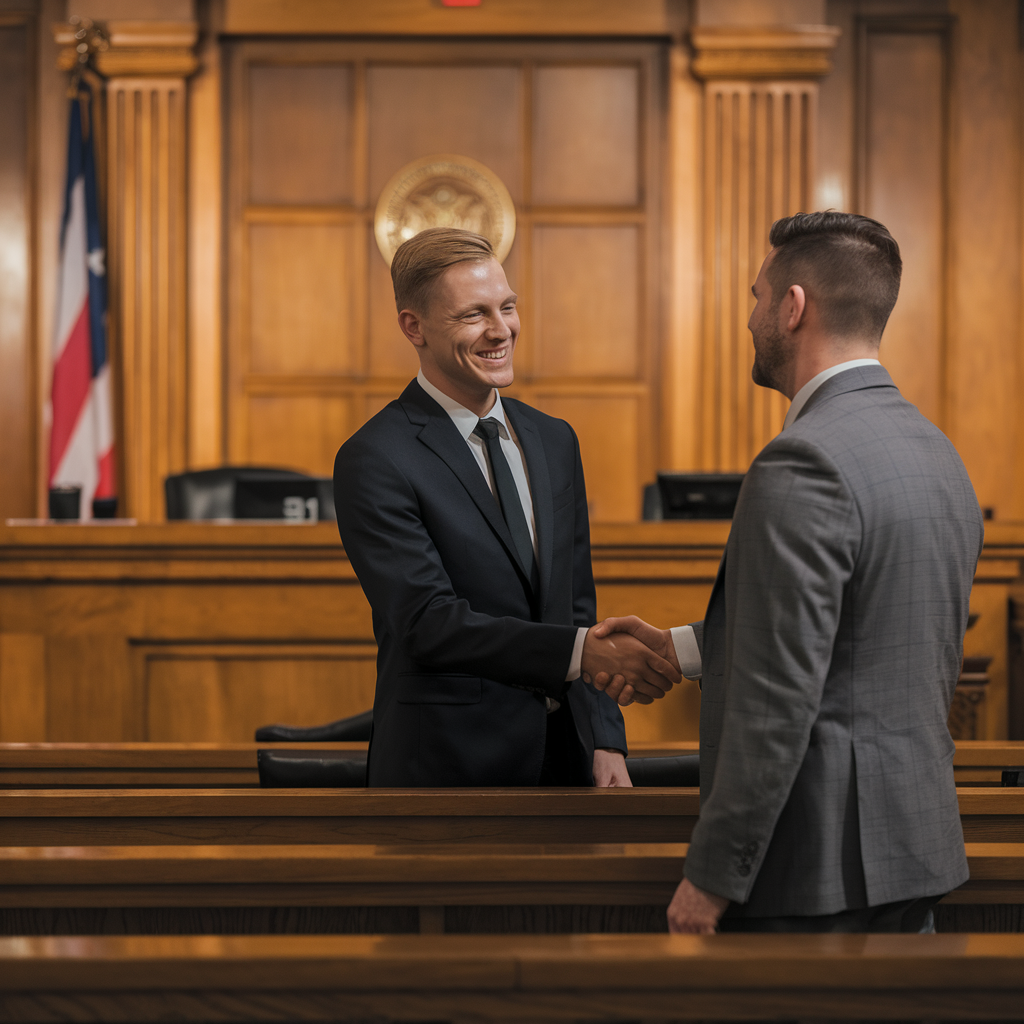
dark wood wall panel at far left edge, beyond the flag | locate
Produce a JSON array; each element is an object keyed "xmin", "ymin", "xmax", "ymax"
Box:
[{"xmin": 0, "ymin": 18, "xmax": 38, "ymax": 520}]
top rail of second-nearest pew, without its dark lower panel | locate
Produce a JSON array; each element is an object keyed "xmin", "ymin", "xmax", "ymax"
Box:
[{"xmin": 0, "ymin": 843, "xmax": 1011, "ymax": 907}]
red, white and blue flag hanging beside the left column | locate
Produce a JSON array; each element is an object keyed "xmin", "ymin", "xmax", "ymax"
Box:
[{"xmin": 50, "ymin": 82, "xmax": 117, "ymax": 519}]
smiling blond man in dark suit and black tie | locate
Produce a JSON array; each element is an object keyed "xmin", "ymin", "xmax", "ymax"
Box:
[{"xmin": 334, "ymin": 228, "xmax": 680, "ymax": 786}]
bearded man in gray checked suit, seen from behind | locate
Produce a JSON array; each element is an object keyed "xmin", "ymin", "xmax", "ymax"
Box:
[{"xmin": 595, "ymin": 212, "xmax": 983, "ymax": 934}]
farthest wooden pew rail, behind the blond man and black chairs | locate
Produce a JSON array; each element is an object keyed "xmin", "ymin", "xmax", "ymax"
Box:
[{"xmin": 0, "ymin": 740, "xmax": 1024, "ymax": 790}]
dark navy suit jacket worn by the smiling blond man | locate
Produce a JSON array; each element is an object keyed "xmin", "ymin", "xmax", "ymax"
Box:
[{"xmin": 334, "ymin": 381, "xmax": 626, "ymax": 786}]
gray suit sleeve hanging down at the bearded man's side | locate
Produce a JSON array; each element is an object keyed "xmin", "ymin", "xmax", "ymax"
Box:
[{"xmin": 685, "ymin": 435, "xmax": 861, "ymax": 903}]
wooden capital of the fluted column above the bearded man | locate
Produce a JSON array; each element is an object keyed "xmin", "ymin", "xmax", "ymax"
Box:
[{"xmin": 689, "ymin": 25, "xmax": 841, "ymax": 79}]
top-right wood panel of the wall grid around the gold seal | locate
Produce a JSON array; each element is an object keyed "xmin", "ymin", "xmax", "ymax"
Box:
[{"xmin": 532, "ymin": 66, "xmax": 640, "ymax": 206}]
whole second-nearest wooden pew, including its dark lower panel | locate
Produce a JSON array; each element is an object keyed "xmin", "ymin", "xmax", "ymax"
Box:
[{"xmin": 0, "ymin": 843, "xmax": 1024, "ymax": 935}]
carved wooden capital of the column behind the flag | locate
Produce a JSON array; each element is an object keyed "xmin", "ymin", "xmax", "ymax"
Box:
[{"xmin": 53, "ymin": 22, "xmax": 199, "ymax": 78}]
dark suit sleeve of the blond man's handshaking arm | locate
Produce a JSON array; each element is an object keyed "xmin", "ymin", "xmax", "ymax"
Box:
[{"xmin": 334, "ymin": 438, "xmax": 577, "ymax": 697}]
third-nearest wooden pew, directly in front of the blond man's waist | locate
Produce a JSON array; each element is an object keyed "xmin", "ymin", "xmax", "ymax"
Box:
[{"xmin": 0, "ymin": 786, "xmax": 1024, "ymax": 846}]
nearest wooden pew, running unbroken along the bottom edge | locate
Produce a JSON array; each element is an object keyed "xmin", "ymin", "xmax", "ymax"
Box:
[{"xmin": 0, "ymin": 935, "xmax": 1024, "ymax": 1024}]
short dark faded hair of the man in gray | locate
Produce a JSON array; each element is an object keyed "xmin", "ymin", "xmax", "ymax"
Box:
[{"xmin": 765, "ymin": 210, "xmax": 903, "ymax": 341}]
